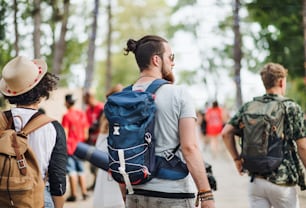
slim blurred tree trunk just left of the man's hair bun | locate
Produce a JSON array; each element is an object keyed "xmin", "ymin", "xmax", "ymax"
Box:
[{"xmin": 105, "ymin": 0, "xmax": 112, "ymax": 90}]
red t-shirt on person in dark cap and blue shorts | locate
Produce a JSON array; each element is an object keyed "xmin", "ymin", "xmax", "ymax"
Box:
[{"xmin": 62, "ymin": 108, "xmax": 89, "ymax": 155}]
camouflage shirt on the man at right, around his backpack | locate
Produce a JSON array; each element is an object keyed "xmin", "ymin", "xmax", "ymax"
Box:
[{"xmin": 229, "ymin": 94, "xmax": 306, "ymax": 190}]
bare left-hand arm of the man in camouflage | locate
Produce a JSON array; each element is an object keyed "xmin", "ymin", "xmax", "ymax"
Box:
[{"xmin": 221, "ymin": 124, "xmax": 243, "ymax": 175}]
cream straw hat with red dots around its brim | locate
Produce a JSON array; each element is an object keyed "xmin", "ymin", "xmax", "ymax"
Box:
[{"xmin": 0, "ymin": 56, "xmax": 48, "ymax": 96}]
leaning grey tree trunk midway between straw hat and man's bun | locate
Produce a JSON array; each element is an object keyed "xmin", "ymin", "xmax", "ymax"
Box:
[{"xmin": 84, "ymin": 0, "xmax": 99, "ymax": 91}]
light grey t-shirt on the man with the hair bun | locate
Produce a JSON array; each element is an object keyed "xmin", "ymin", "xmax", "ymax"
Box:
[{"xmin": 133, "ymin": 82, "xmax": 196, "ymax": 193}]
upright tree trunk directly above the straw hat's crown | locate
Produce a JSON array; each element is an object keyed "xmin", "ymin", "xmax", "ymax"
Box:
[{"xmin": 33, "ymin": 0, "xmax": 41, "ymax": 58}]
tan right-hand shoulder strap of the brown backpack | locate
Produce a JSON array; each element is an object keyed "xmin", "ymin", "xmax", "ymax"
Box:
[{"xmin": 21, "ymin": 112, "xmax": 54, "ymax": 135}]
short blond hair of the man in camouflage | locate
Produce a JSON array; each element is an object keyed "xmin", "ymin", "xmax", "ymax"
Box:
[{"xmin": 260, "ymin": 63, "xmax": 288, "ymax": 89}]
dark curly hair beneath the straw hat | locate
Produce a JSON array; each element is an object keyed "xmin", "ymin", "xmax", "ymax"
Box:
[{"xmin": 4, "ymin": 72, "xmax": 59, "ymax": 105}]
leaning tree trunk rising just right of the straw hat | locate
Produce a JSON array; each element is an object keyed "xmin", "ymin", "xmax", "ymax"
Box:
[{"xmin": 53, "ymin": 0, "xmax": 70, "ymax": 75}]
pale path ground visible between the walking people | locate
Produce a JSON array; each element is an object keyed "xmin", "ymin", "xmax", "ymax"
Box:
[{"xmin": 64, "ymin": 145, "xmax": 306, "ymax": 208}]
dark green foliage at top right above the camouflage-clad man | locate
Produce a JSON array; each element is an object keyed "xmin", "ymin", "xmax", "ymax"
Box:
[{"xmin": 246, "ymin": 0, "xmax": 304, "ymax": 77}]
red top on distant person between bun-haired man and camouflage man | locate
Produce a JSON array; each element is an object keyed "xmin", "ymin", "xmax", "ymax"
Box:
[{"xmin": 205, "ymin": 107, "xmax": 223, "ymax": 136}]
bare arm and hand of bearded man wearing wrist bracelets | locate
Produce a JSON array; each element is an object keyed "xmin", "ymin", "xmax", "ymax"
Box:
[{"xmin": 179, "ymin": 118, "xmax": 215, "ymax": 208}]
